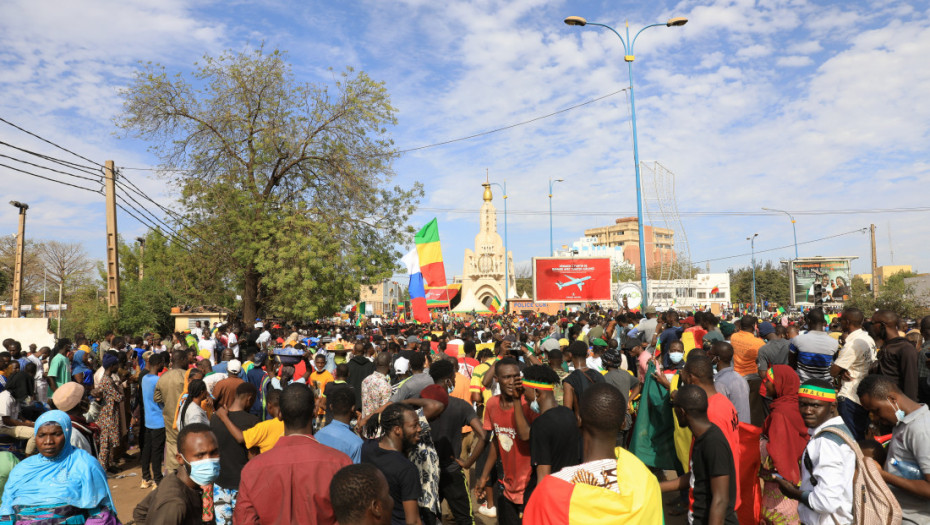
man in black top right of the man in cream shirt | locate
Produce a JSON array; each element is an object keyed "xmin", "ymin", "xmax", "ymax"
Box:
[{"xmin": 869, "ymin": 310, "xmax": 920, "ymax": 399}]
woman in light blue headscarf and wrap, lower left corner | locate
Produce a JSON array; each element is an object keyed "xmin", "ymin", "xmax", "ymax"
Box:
[{"xmin": 0, "ymin": 410, "xmax": 119, "ymax": 525}]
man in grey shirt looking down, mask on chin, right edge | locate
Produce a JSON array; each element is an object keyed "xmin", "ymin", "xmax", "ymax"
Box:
[{"xmin": 856, "ymin": 375, "xmax": 930, "ymax": 523}]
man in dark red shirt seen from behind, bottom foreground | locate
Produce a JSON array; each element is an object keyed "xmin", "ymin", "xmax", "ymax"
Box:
[{"xmin": 234, "ymin": 383, "xmax": 352, "ymax": 524}]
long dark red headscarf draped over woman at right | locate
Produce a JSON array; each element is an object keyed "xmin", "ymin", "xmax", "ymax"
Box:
[{"xmin": 762, "ymin": 365, "xmax": 810, "ymax": 483}]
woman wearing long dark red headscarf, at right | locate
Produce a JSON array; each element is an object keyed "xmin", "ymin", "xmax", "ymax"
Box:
[{"xmin": 759, "ymin": 365, "xmax": 810, "ymax": 525}]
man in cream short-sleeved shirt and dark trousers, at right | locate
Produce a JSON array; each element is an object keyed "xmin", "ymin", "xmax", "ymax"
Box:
[{"xmin": 830, "ymin": 308, "xmax": 875, "ymax": 441}]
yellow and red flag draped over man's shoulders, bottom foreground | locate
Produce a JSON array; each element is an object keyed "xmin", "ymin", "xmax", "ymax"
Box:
[{"xmin": 523, "ymin": 447, "xmax": 663, "ymax": 525}]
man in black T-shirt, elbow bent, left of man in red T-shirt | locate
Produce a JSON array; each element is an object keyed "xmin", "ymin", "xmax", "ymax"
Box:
[{"xmin": 420, "ymin": 359, "xmax": 486, "ymax": 524}]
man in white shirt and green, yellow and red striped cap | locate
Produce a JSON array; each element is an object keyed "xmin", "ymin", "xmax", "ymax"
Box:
[{"xmin": 775, "ymin": 379, "xmax": 856, "ymax": 525}]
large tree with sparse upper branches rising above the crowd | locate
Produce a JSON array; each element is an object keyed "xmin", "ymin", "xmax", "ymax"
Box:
[{"xmin": 118, "ymin": 49, "xmax": 422, "ymax": 320}]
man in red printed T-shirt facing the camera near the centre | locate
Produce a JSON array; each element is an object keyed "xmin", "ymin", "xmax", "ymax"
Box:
[{"xmin": 477, "ymin": 357, "xmax": 536, "ymax": 525}]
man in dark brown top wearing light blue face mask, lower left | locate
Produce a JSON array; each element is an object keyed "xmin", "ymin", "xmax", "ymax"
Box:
[{"xmin": 132, "ymin": 423, "xmax": 220, "ymax": 525}]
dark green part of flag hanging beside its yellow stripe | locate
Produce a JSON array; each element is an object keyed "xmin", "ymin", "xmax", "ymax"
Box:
[{"xmin": 630, "ymin": 363, "xmax": 677, "ymax": 470}]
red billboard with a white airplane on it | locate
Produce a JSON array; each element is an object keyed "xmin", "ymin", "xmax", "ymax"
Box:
[{"xmin": 533, "ymin": 257, "xmax": 613, "ymax": 303}]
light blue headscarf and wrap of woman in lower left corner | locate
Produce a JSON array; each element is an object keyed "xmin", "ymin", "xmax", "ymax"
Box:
[{"xmin": 0, "ymin": 410, "xmax": 115, "ymax": 516}]
